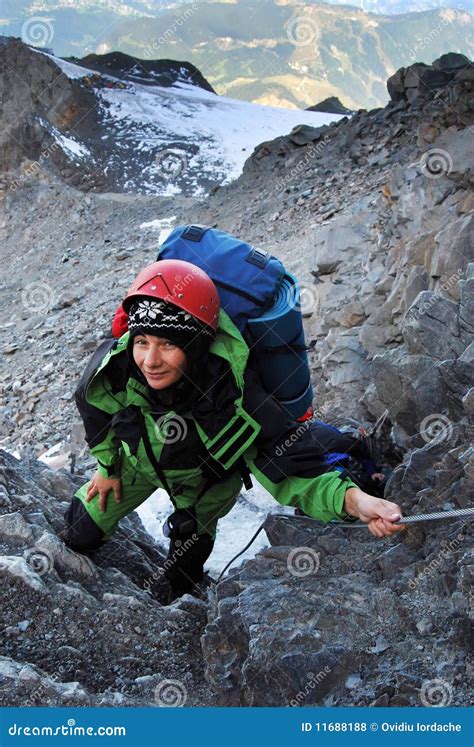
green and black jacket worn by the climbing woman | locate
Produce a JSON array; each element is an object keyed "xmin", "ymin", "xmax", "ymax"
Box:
[{"xmin": 75, "ymin": 311, "xmax": 353, "ymax": 521}]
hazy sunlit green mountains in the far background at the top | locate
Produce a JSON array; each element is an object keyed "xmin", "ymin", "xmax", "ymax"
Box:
[{"xmin": 4, "ymin": 0, "xmax": 474, "ymax": 110}]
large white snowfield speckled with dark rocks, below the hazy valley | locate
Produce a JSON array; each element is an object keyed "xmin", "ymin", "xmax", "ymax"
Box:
[{"xmin": 41, "ymin": 48, "xmax": 341, "ymax": 196}]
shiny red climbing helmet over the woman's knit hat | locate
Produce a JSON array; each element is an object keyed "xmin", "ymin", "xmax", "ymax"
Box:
[{"xmin": 122, "ymin": 259, "xmax": 220, "ymax": 331}]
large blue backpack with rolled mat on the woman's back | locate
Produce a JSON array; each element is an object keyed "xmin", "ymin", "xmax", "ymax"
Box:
[{"xmin": 158, "ymin": 225, "xmax": 313, "ymax": 420}]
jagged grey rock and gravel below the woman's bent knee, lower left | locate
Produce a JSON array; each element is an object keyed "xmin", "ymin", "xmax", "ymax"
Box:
[{"xmin": 0, "ymin": 451, "xmax": 208, "ymax": 707}]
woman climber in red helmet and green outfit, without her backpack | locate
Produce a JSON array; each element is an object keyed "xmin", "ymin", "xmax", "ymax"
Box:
[{"xmin": 64, "ymin": 260, "xmax": 404, "ymax": 596}]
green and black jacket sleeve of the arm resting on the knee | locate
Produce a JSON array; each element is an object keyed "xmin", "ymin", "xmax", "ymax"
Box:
[{"xmin": 74, "ymin": 340, "xmax": 126, "ymax": 477}]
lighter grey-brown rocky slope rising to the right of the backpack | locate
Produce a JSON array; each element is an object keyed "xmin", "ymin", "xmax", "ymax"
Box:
[{"xmin": 178, "ymin": 55, "xmax": 474, "ymax": 432}]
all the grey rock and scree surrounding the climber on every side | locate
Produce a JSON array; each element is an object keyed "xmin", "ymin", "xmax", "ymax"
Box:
[{"xmin": 0, "ymin": 51, "xmax": 474, "ymax": 706}]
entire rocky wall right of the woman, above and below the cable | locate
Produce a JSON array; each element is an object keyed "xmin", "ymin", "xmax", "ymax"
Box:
[{"xmin": 175, "ymin": 56, "xmax": 474, "ymax": 706}]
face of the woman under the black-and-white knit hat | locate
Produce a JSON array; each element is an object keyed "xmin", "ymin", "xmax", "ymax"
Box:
[{"xmin": 133, "ymin": 335, "xmax": 188, "ymax": 389}]
